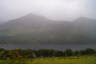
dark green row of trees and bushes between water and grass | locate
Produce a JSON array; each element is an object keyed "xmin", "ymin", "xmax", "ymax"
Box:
[{"xmin": 0, "ymin": 48, "xmax": 96, "ymax": 59}]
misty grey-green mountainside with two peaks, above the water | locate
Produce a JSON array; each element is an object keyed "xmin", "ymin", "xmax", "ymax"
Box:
[{"xmin": 0, "ymin": 14, "xmax": 96, "ymax": 45}]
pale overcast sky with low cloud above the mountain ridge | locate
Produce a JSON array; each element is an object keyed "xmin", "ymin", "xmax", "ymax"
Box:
[{"xmin": 0, "ymin": 0, "xmax": 96, "ymax": 22}]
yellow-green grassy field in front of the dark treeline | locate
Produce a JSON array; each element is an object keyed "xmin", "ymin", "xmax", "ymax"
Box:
[{"xmin": 0, "ymin": 55, "xmax": 96, "ymax": 64}]
